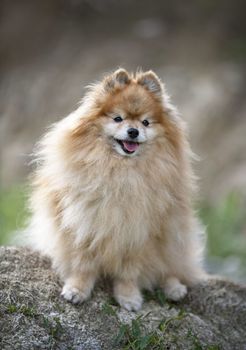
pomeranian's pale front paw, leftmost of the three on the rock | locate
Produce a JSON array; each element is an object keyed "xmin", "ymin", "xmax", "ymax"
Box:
[{"xmin": 61, "ymin": 271, "xmax": 96, "ymax": 304}]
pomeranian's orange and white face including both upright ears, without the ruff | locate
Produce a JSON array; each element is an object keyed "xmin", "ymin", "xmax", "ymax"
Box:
[{"xmin": 94, "ymin": 70, "xmax": 175, "ymax": 157}]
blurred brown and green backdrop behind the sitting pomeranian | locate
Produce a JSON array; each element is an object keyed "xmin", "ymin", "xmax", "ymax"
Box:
[{"xmin": 0, "ymin": 0, "xmax": 246, "ymax": 282}]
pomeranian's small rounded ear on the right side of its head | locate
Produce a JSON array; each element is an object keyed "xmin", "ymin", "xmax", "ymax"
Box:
[{"xmin": 137, "ymin": 70, "xmax": 163, "ymax": 99}]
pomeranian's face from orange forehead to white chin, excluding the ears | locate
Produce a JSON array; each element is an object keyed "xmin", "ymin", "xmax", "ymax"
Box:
[{"xmin": 102, "ymin": 84, "xmax": 164, "ymax": 157}]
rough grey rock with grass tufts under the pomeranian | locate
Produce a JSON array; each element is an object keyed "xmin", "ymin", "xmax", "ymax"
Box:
[{"xmin": 0, "ymin": 247, "xmax": 246, "ymax": 350}]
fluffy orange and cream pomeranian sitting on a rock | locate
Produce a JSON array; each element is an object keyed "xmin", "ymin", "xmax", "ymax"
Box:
[{"xmin": 30, "ymin": 69, "xmax": 205, "ymax": 310}]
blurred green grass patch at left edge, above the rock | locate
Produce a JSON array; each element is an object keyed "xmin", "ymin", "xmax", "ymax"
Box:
[{"xmin": 0, "ymin": 185, "xmax": 28, "ymax": 245}]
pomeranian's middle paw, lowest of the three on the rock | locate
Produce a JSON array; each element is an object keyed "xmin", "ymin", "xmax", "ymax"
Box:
[{"xmin": 114, "ymin": 279, "xmax": 143, "ymax": 311}]
